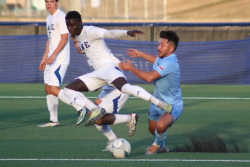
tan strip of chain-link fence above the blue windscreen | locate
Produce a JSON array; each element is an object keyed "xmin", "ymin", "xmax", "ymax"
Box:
[{"xmin": 0, "ymin": 22, "xmax": 250, "ymax": 42}]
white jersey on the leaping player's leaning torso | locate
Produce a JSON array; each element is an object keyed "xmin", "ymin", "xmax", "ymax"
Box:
[{"xmin": 77, "ymin": 26, "xmax": 120, "ymax": 70}]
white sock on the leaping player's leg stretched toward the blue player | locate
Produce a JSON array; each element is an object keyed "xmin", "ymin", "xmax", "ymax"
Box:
[{"xmin": 122, "ymin": 83, "xmax": 160, "ymax": 106}]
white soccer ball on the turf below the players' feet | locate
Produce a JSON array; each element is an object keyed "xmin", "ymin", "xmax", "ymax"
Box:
[{"xmin": 110, "ymin": 138, "xmax": 131, "ymax": 158}]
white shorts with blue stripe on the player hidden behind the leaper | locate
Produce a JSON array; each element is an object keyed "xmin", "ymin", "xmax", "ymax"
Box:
[{"xmin": 98, "ymin": 87, "xmax": 129, "ymax": 114}]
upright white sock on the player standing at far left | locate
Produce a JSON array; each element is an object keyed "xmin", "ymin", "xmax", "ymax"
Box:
[{"xmin": 46, "ymin": 95, "xmax": 58, "ymax": 122}]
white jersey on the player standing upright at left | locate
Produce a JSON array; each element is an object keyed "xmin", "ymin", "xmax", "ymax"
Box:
[{"xmin": 46, "ymin": 9, "xmax": 70, "ymax": 64}]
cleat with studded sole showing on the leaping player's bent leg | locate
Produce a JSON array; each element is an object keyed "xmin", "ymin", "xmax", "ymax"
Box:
[{"xmin": 85, "ymin": 107, "xmax": 106, "ymax": 126}]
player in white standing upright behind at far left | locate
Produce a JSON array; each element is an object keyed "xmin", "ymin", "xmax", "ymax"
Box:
[{"xmin": 38, "ymin": 0, "xmax": 82, "ymax": 127}]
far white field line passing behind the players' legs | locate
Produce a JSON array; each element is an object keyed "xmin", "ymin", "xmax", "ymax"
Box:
[{"xmin": 0, "ymin": 96, "xmax": 250, "ymax": 100}]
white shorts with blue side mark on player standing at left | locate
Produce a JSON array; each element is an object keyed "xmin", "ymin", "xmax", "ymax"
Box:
[{"xmin": 44, "ymin": 64, "xmax": 69, "ymax": 87}]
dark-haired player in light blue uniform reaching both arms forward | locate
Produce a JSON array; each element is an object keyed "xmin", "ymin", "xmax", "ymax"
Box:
[{"xmin": 119, "ymin": 31, "xmax": 183, "ymax": 155}]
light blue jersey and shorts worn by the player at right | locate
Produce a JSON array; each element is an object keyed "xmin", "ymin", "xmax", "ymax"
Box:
[{"xmin": 148, "ymin": 54, "xmax": 183, "ymax": 121}]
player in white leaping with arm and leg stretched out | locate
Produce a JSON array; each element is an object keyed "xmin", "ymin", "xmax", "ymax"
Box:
[{"xmin": 64, "ymin": 11, "xmax": 172, "ymax": 126}]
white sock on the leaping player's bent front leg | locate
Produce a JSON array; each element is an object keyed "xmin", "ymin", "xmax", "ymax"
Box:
[{"xmin": 63, "ymin": 88, "xmax": 97, "ymax": 110}]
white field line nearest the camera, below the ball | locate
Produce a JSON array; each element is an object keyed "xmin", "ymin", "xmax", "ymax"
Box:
[{"xmin": 0, "ymin": 158, "xmax": 250, "ymax": 163}]
